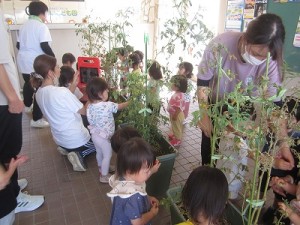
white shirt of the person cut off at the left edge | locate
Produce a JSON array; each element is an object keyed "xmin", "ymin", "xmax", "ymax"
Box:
[{"xmin": 0, "ymin": 10, "xmax": 21, "ymax": 105}]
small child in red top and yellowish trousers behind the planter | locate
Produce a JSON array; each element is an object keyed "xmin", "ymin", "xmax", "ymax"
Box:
[{"xmin": 168, "ymin": 75, "xmax": 187, "ymax": 146}]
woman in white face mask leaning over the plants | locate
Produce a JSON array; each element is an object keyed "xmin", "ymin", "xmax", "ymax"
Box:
[{"xmin": 197, "ymin": 14, "xmax": 294, "ymax": 169}]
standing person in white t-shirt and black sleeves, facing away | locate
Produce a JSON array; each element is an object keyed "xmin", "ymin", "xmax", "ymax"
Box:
[{"xmin": 17, "ymin": 1, "xmax": 54, "ymax": 128}]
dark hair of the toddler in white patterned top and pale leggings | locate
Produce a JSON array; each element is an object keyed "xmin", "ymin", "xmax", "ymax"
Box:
[{"xmin": 86, "ymin": 77, "xmax": 108, "ymax": 102}]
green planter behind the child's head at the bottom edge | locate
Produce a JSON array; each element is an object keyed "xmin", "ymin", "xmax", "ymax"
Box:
[{"xmin": 167, "ymin": 187, "xmax": 247, "ymax": 225}]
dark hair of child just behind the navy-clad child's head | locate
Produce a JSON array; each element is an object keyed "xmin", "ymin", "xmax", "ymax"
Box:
[{"xmin": 110, "ymin": 126, "xmax": 142, "ymax": 153}]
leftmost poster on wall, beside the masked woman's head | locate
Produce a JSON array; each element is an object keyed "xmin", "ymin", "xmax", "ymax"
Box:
[{"xmin": 225, "ymin": 0, "xmax": 244, "ymax": 31}]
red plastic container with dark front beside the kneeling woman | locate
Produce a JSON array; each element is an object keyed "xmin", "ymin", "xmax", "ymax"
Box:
[{"xmin": 77, "ymin": 56, "xmax": 101, "ymax": 103}]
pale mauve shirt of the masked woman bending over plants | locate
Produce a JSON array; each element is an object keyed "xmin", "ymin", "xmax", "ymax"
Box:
[{"xmin": 197, "ymin": 32, "xmax": 281, "ymax": 101}]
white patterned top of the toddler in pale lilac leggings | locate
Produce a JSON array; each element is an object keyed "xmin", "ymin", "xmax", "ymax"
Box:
[{"xmin": 86, "ymin": 102, "xmax": 118, "ymax": 139}]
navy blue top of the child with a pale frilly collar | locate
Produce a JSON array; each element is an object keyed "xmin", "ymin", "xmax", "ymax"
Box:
[{"xmin": 110, "ymin": 193, "xmax": 151, "ymax": 225}]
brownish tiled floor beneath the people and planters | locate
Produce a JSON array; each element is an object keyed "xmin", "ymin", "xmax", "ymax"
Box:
[{"xmin": 15, "ymin": 101, "xmax": 201, "ymax": 225}]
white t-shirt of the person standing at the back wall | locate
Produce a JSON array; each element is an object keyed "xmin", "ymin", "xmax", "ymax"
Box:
[{"xmin": 17, "ymin": 19, "xmax": 52, "ymax": 74}]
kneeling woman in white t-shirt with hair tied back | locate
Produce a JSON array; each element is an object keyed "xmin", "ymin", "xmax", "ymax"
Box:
[{"xmin": 31, "ymin": 55, "xmax": 95, "ymax": 171}]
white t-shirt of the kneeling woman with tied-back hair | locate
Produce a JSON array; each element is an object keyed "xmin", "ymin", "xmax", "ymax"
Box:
[{"xmin": 36, "ymin": 85, "xmax": 90, "ymax": 148}]
